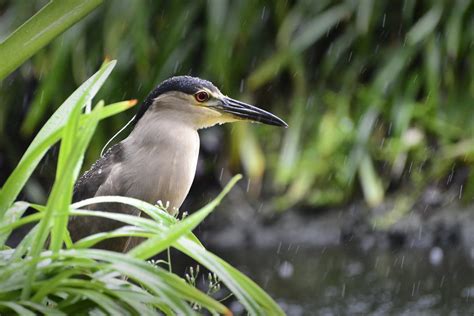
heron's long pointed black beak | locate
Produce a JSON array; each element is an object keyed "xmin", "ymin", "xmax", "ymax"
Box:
[{"xmin": 219, "ymin": 97, "xmax": 288, "ymax": 127}]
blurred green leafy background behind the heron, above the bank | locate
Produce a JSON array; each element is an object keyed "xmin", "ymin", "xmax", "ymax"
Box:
[{"xmin": 0, "ymin": 0, "xmax": 474, "ymax": 212}]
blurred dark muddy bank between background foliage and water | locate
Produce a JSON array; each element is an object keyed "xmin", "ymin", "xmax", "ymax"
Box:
[{"xmin": 198, "ymin": 186, "xmax": 474, "ymax": 257}]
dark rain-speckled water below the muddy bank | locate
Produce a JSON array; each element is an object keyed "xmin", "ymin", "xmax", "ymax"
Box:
[{"xmin": 215, "ymin": 245, "xmax": 474, "ymax": 315}]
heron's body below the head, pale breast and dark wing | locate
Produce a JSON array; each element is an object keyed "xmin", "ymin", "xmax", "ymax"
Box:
[{"xmin": 70, "ymin": 111, "xmax": 199, "ymax": 251}]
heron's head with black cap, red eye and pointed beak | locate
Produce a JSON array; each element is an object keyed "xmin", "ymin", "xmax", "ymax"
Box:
[{"xmin": 135, "ymin": 76, "xmax": 288, "ymax": 128}]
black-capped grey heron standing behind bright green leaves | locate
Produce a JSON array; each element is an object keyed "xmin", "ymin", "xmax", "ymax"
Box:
[{"xmin": 68, "ymin": 76, "xmax": 288, "ymax": 252}]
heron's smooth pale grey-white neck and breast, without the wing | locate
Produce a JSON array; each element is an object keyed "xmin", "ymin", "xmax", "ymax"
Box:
[{"xmin": 123, "ymin": 112, "xmax": 199, "ymax": 208}]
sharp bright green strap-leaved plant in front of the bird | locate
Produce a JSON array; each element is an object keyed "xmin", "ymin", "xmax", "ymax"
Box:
[{"xmin": 0, "ymin": 61, "xmax": 283, "ymax": 315}]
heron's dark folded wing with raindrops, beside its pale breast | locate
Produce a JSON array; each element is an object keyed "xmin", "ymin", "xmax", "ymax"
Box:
[{"xmin": 73, "ymin": 143, "xmax": 122, "ymax": 202}]
